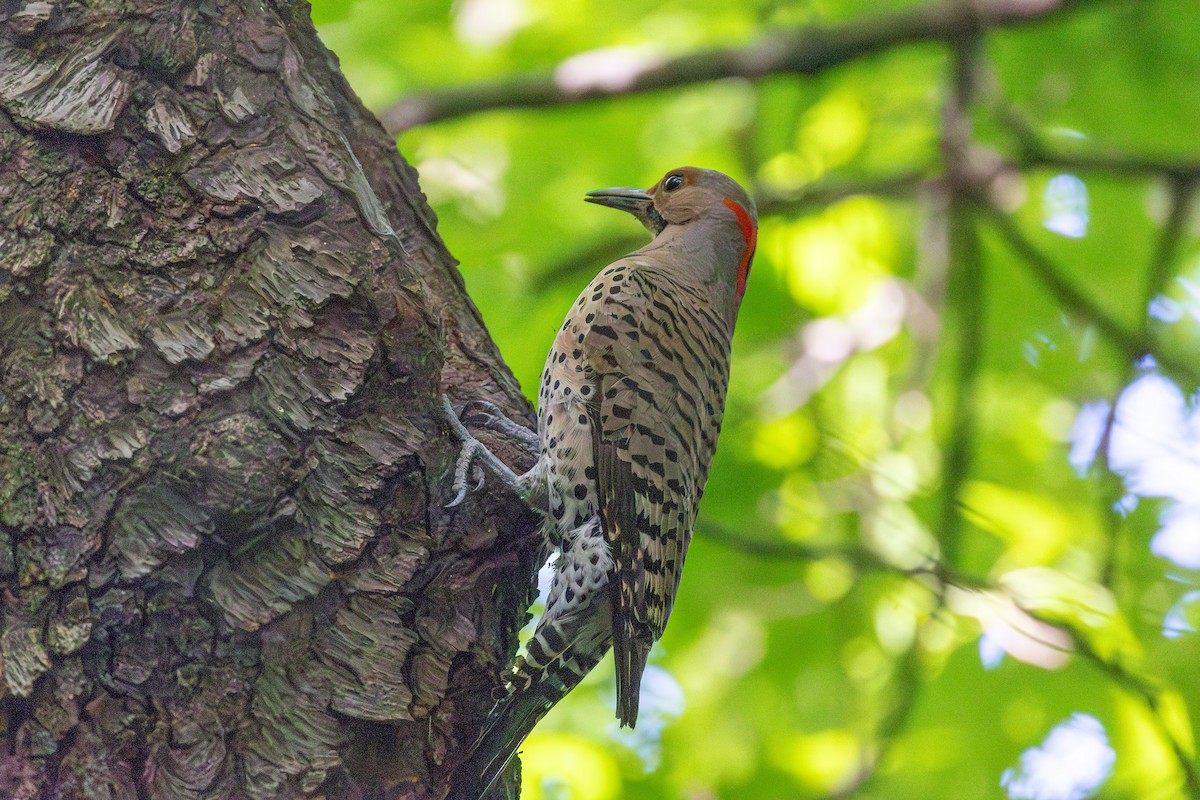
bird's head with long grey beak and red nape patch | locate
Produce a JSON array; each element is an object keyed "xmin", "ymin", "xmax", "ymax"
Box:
[{"xmin": 584, "ymin": 167, "xmax": 758, "ymax": 302}]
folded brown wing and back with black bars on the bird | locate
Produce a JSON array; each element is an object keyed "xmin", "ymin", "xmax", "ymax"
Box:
[{"xmin": 582, "ymin": 263, "xmax": 728, "ymax": 726}]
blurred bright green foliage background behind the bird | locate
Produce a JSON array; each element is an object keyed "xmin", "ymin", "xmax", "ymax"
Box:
[{"xmin": 312, "ymin": 0, "xmax": 1200, "ymax": 800}]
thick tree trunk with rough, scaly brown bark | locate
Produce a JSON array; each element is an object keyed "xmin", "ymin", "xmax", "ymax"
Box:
[{"xmin": 0, "ymin": 0, "xmax": 536, "ymax": 800}]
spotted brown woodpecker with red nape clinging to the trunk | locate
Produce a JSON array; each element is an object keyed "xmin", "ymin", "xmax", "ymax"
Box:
[{"xmin": 451, "ymin": 167, "xmax": 757, "ymax": 800}]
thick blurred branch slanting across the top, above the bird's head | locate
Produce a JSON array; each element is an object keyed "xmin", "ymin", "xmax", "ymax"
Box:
[{"xmin": 379, "ymin": 0, "xmax": 1096, "ymax": 134}]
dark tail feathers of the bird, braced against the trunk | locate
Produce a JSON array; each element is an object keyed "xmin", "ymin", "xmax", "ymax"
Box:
[{"xmin": 448, "ymin": 681, "xmax": 566, "ymax": 800}]
